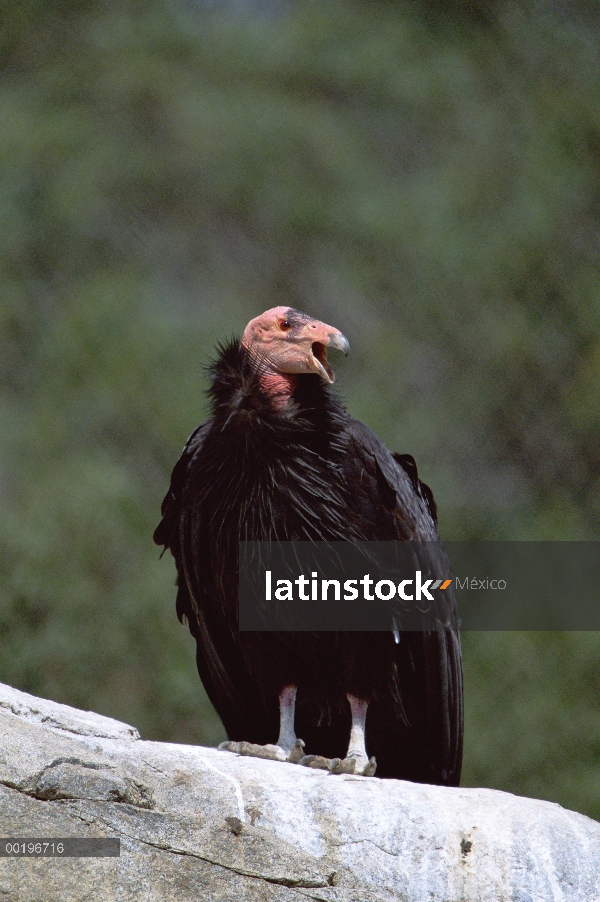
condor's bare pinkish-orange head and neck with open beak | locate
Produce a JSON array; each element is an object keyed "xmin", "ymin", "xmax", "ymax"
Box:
[{"xmin": 242, "ymin": 307, "xmax": 350, "ymax": 407}]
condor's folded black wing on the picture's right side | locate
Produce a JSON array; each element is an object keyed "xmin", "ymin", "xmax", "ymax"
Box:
[{"xmin": 348, "ymin": 420, "xmax": 463, "ymax": 785}]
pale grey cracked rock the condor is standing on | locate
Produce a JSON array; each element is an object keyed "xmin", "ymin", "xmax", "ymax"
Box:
[{"xmin": 0, "ymin": 685, "xmax": 600, "ymax": 902}]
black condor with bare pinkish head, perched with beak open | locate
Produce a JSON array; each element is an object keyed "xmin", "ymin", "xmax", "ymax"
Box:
[{"xmin": 154, "ymin": 306, "xmax": 463, "ymax": 786}]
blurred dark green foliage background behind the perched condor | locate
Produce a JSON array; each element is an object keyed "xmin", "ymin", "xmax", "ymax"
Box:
[{"xmin": 0, "ymin": 0, "xmax": 600, "ymax": 817}]
